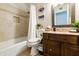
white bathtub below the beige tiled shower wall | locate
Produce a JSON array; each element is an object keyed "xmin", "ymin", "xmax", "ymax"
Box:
[{"xmin": 0, "ymin": 37, "xmax": 27, "ymax": 56}]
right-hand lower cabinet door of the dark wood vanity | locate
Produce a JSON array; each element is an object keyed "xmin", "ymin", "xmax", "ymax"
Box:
[{"xmin": 62, "ymin": 43, "xmax": 79, "ymax": 56}]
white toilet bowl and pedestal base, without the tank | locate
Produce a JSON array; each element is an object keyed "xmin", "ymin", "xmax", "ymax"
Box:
[{"xmin": 28, "ymin": 38, "xmax": 41, "ymax": 56}]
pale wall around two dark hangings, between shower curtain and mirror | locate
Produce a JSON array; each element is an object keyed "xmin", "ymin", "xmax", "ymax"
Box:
[{"xmin": 37, "ymin": 3, "xmax": 52, "ymax": 28}]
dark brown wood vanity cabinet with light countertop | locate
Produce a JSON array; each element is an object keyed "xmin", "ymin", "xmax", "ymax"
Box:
[{"xmin": 43, "ymin": 31, "xmax": 79, "ymax": 56}]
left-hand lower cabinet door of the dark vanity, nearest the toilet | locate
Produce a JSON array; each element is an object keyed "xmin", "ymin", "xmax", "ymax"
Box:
[{"xmin": 44, "ymin": 40, "xmax": 61, "ymax": 56}]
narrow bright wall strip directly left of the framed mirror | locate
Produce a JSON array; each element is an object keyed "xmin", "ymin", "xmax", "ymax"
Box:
[{"xmin": 45, "ymin": 4, "xmax": 52, "ymax": 27}]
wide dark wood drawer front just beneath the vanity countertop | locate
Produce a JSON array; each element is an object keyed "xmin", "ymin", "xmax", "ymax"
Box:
[{"xmin": 48, "ymin": 34, "xmax": 77, "ymax": 44}]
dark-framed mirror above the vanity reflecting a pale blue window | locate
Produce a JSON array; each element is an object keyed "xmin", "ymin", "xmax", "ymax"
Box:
[{"xmin": 52, "ymin": 3, "xmax": 75, "ymax": 27}]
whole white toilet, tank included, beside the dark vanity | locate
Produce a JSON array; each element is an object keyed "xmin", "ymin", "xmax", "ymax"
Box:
[{"xmin": 28, "ymin": 29, "xmax": 44, "ymax": 56}]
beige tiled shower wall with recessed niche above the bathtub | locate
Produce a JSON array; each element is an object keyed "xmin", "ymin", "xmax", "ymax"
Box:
[{"xmin": 0, "ymin": 3, "xmax": 29, "ymax": 42}]
